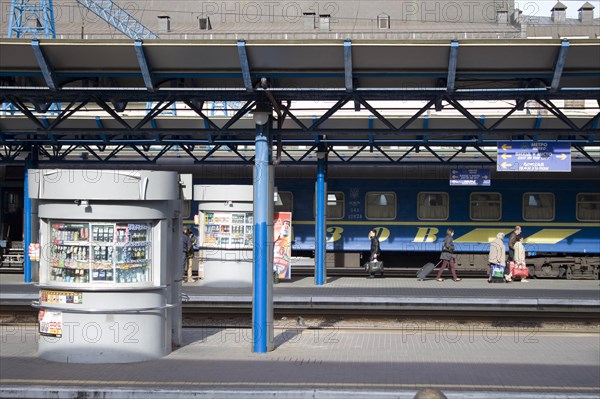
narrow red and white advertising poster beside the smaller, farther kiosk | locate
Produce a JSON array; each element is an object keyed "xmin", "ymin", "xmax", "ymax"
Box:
[{"xmin": 273, "ymin": 212, "xmax": 292, "ymax": 280}]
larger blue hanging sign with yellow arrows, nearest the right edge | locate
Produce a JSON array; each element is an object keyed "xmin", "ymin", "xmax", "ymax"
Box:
[{"xmin": 496, "ymin": 141, "xmax": 571, "ymax": 172}]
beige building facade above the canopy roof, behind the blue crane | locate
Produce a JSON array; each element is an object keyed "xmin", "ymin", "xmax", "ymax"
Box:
[{"xmin": 0, "ymin": 0, "xmax": 600, "ymax": 40}]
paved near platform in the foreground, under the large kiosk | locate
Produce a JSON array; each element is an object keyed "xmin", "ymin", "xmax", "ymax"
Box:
[{"xmin": 0, "ymin": 327, "xmax": 600, "ymax": 399}]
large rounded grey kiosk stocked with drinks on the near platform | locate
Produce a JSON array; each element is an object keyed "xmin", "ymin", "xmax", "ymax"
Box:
[{"xmin": 29, "ymin": 170, "xmax": 183, "ymax": 363}]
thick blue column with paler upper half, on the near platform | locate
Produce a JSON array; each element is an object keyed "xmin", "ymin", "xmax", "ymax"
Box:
[{"xmin": 252, "ymin": 117, "xmax": 273, "ymax": 353}]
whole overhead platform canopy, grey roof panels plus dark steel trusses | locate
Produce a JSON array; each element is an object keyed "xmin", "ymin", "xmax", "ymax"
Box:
[{"xmin": 0, "ymin": 39, "xmax": 600, "ymax": 163}]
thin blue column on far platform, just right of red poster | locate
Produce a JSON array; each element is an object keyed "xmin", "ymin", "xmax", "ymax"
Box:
[{"xmin": 315, "ymin": 150, "xmax": 327, "ymax": 285}]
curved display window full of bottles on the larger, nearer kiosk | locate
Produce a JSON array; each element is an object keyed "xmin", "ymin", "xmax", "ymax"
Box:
[{"xmin": 47, "ymin": 221, "xmax": 153, "ymax": 285}]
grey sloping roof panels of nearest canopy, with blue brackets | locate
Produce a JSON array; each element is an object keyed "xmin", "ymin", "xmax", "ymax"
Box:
[{"xmin": 0, "ymin": 39, "xmax": 600, "ymax": 93}]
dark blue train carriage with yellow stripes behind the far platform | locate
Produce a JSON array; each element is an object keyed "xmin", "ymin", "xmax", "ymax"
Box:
[{"xmin": 276, "ymin": 171, "xmax": 600, "ymax": 278}]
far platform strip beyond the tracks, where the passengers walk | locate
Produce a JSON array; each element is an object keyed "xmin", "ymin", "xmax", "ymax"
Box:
[{"xmin": 0, "ymin": 274, "xmax": 600, "ymax": 317}]
